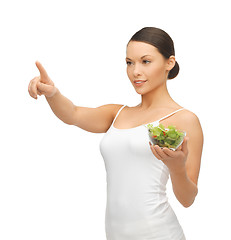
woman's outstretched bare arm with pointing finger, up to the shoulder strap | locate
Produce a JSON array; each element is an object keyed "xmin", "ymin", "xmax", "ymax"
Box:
[{"xmin": 28, "ymin": 61, "xmax": 122, "ymax": 133}]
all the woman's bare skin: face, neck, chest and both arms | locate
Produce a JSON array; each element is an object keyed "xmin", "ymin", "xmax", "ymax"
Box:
[{"xmin": 28, "ymin": 41, "xmax": 203, "ymax": 207}]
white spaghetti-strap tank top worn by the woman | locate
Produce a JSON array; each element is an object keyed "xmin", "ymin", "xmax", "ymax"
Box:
[{"xmin": 100, "ymin": 105, "xmax": 186, "ymax": 240}]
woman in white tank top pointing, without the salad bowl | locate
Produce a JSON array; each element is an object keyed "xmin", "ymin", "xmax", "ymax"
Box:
[{"xmin": 28, "ymin": 27, "xmax": 203, "ymax": 240}]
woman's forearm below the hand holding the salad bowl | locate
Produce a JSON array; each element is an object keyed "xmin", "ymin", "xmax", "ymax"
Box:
[{"xmin": 170, "ymin": 169, "xmax": 198, "ymax": 207}]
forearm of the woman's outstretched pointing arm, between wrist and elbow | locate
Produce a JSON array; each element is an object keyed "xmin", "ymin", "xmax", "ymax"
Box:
[{"xmin": 46, "ymin": 89, "xmax": 75, "ymax": 124}]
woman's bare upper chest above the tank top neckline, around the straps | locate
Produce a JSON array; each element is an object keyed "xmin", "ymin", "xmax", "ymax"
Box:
[{"xmin": 113, "ymin": 105, "xmax": 192, "ymax": 129}]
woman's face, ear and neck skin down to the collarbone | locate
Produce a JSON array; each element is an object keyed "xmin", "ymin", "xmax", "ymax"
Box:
[{"xmin": 126, "ymin": 41, "xmax": 179, "ymax": 110}]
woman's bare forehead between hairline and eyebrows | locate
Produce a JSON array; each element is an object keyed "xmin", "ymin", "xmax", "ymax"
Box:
[{"xmin": 126, "ymin": 41, "xmax": 159, "ymax": 57}]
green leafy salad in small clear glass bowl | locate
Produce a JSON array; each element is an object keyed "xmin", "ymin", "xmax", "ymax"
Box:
[{"xmin": 145, "ymin": 123, "xmax": 186, "ymax": 150}]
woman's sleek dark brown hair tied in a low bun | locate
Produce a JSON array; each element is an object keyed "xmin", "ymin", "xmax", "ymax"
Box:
[{"xmin": 127, "ymin": 27, "xmax": 180, "ymax": 79}]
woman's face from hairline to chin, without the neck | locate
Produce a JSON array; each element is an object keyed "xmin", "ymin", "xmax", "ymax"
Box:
[{"xmin": 126, "ymin": 41, "xmax": 173, "ymax": 94}]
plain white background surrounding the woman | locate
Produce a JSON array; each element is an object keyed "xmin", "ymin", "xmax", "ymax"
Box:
[{"xmin": 0, "ymin": 0, "xmax": 231, "ymax": 240}]
